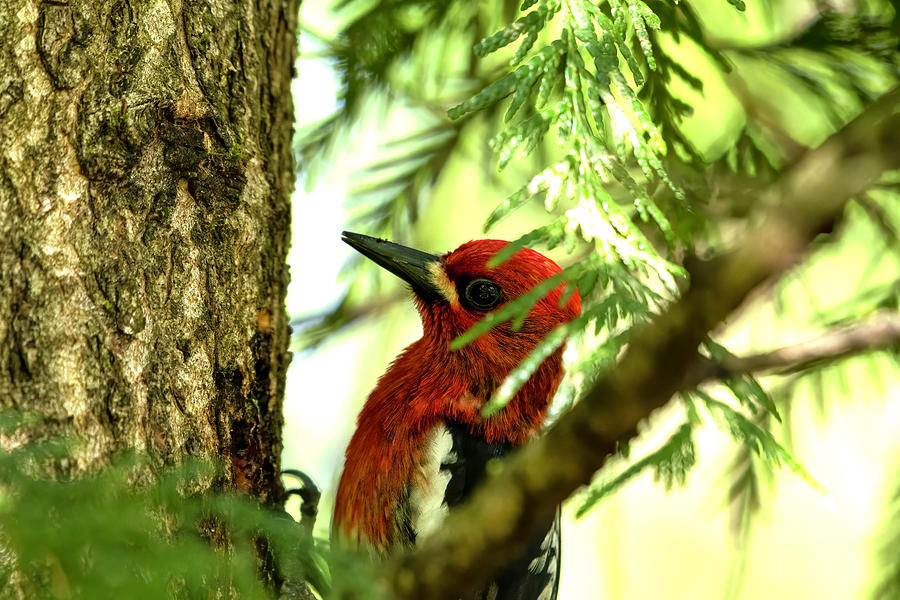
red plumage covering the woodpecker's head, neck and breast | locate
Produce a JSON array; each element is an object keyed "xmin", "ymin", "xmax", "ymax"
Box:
[{"xmin": 334, "ymin": 238, "xmax": 581, "ymax": 551}]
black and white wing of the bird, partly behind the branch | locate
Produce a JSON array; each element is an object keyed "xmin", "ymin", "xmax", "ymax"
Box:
[{"xmin": 398, "ymin": 424, "xmax": 560, "ymax": 600}]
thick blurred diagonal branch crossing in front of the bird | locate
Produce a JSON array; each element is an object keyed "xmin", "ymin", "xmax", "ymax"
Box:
[{"xmin": 385, "ymin": 88, "xmax": 900, "ymax": 600}]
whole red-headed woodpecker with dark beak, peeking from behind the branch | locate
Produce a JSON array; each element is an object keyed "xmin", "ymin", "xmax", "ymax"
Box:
[{"xmin": 333, "ymin": 231, "xmax": 581, "ymax": 600}]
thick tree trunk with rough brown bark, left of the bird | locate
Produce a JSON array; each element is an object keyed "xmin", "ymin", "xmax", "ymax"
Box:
[{"xmin": 0, "ymin": 0, "xmax": 299, "ymax": 502}]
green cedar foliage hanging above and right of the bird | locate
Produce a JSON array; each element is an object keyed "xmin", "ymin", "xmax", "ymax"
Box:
[{"xmin": 295, "ymin": 0, "xmax": 900, "ymax": 597}]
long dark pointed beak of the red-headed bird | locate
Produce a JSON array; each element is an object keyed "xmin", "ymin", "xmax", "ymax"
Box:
[{"xmin": 341, "ymin": 231, "xmax": 444, "ymax": 302}]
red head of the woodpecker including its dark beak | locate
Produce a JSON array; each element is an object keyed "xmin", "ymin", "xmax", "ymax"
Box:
[{"xmin": 343, "ymin": 232, "xmax": 581, "ymax": 380}]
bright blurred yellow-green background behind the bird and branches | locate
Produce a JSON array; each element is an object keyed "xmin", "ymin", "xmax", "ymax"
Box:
[{"xmin": 283, "ymin": 0, "xmax": 900, "ymax": 600}]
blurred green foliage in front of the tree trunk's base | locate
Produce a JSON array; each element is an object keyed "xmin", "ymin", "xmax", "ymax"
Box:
[{"xmin": 0, "ymin": 411, "xmax": 329, "ymax": 598}]
